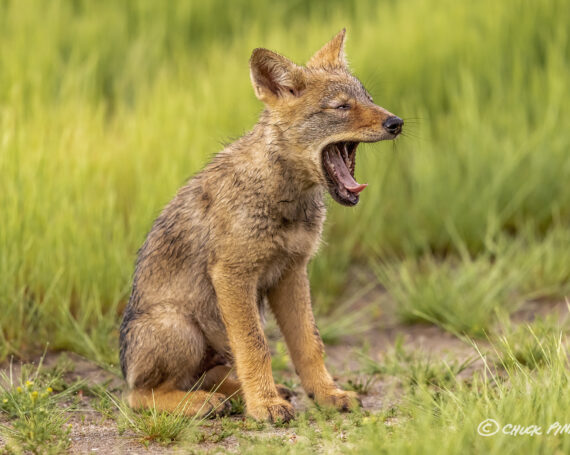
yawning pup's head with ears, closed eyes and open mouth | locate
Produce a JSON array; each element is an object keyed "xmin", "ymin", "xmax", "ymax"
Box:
[{"xmin": 250, "ymin": 29, "xmax": 404, "ymax": 206}]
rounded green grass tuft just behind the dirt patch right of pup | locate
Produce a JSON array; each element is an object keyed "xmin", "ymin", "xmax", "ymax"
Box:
[{"xmin": 377, "ymin": 251, "xmax": 515, "ymax": 336}]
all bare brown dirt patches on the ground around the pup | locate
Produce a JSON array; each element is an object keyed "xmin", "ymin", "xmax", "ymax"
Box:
[{"xmin": 0, "ymin": 294, "xmax": 568, "ymax": 454}]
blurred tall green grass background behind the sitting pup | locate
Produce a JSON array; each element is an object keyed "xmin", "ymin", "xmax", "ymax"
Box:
[{"xmin": 0, "ymin": 0, "xmax": 570, "ymax": 362}]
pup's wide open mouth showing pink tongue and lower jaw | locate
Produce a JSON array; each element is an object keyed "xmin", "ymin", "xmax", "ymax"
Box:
[{"xmin": 322, "ymin": 142, "xmax": 367, "ymax": 206}]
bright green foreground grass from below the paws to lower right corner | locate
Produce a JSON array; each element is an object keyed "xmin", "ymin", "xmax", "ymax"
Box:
[{"xmin": 192, "ymin": 320, "xmax": 570, "ymax": 454}]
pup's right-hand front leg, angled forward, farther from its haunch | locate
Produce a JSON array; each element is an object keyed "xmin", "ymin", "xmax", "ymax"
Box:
[{"xmin": 269, "ymin": 264, "xmax": 359, "ymax": 411}]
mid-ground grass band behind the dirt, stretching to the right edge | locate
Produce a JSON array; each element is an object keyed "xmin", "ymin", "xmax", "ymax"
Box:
[{"xmin": 374, "ymin": 226, "xmax": 570, "ymax": 337}]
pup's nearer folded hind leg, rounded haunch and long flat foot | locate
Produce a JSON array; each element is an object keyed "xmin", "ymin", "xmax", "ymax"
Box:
[{"xmin": 121, "ymin": 302, "xmax": 229, "ymax": 415}]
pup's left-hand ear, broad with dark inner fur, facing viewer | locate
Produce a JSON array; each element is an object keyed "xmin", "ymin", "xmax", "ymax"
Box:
[{"xmin": 249, "ymin": 48, "xmax": 305, "ymax": 104}]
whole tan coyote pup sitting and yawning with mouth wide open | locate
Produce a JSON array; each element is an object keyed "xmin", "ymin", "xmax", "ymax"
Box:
[{"xmin": 120, "ymin": 30, "xmax": 403, "ymax": 421}]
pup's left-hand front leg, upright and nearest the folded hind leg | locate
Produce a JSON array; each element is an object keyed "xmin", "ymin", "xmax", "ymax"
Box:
[{"xmin": 211, "ymin": 265, "xmax": 294, "ymax": 422}]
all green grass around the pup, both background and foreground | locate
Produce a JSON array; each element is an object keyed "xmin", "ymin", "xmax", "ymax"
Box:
[{"xmin": 0, "ymin": 0, "xmax": 570, "ymax": 453}]
